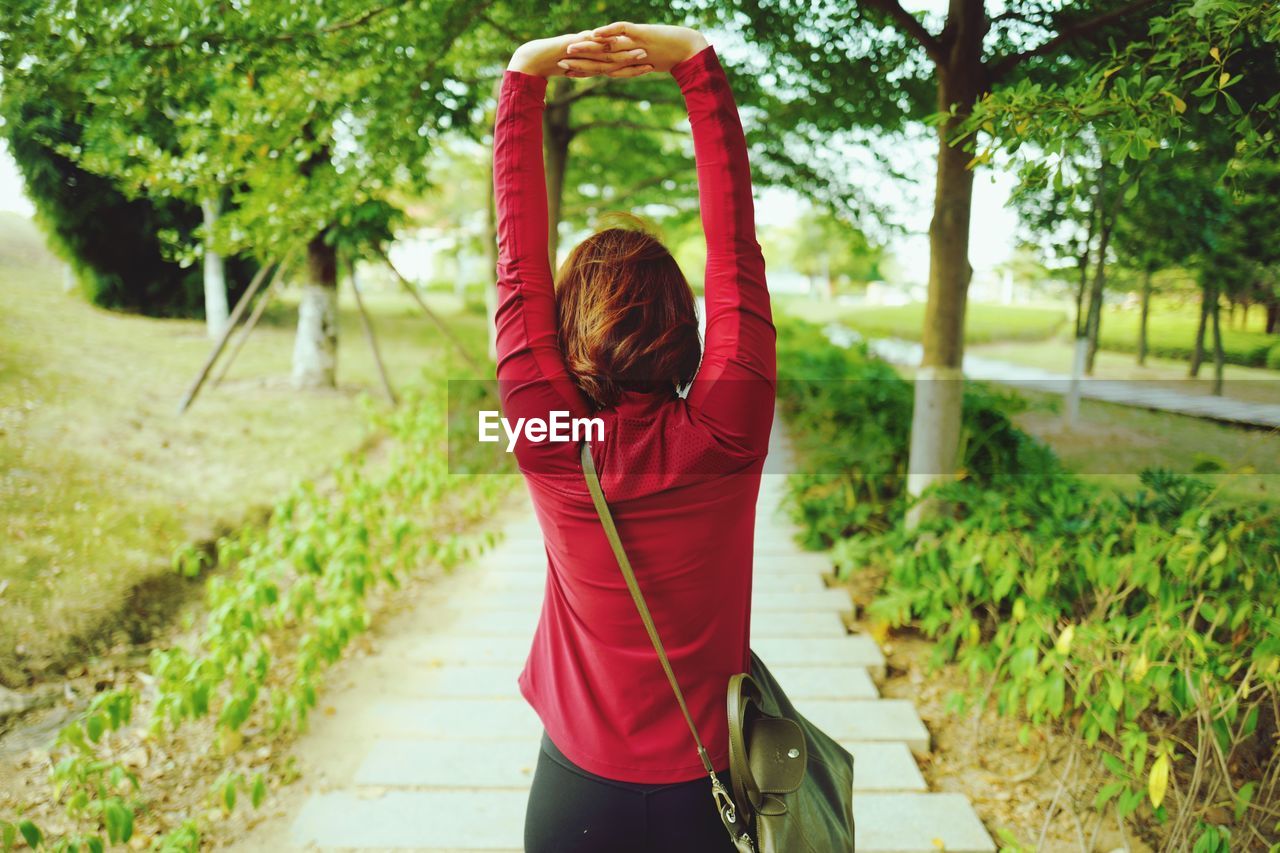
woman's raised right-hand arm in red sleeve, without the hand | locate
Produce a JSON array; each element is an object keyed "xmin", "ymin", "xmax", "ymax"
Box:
[{"xmin": 671, "ymin": 46, "xmax": 777, "ymax": 456}]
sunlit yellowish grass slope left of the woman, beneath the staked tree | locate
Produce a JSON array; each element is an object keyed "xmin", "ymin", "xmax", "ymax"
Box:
[{"xmin": 0, "ymin": 215, "xmax": 484, "ymax": 686}]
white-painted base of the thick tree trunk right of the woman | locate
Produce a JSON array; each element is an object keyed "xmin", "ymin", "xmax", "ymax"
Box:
[{"xmin": 906, "ymin": 366, "xmax": 964, "ymax": 529}]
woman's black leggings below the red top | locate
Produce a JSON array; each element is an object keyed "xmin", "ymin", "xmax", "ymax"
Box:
[{"xmin": 525, "ymin": 731, "xmax": 735, "ymax": 853}]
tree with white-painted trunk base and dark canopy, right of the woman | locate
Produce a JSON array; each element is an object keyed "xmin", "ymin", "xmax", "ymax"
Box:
[{"xmin": 737, "ymin": 0, "xmax": 1172, "ymax": 512}]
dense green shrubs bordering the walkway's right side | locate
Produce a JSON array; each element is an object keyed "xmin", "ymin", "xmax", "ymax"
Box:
[{"xmin": 780, "ymin": 315, "xmax": 1280, "ymax": 850}]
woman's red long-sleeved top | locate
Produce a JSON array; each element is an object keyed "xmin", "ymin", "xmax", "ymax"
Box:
[{"xmin": 494, "ymin": 47, "xmax": 776, "ymax": 783}]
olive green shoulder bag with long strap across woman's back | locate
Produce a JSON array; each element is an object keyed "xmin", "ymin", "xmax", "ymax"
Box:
[{"xmin": 582, "ymin": 444, "xmax": 854, "ymax": 853}]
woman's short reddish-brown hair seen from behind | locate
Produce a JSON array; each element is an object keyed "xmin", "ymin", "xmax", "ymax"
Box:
[{"xmin": 556, "ymin": 216, "xmax": 703, "ymax": 409}]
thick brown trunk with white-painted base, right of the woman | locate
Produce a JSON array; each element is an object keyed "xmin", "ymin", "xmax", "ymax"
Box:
[{"xmin": 906, "ymin": 0, "xmax": 988, "ymax": 526}]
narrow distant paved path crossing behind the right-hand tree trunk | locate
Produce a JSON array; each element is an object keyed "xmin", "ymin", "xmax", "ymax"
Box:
[{"xmin": 844, "ymin": 324, "xmax": 1280, "ymax": 429}]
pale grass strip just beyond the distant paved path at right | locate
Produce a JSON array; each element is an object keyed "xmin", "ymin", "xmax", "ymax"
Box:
[{"xmin": 966, "ymin": 338, "xmax": 1280, "ymax": 403}]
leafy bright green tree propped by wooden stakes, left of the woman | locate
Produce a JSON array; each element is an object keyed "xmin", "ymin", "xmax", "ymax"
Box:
[{"xmin": 0, "ymin": 0, "xmax": 486, "ymax": 387}]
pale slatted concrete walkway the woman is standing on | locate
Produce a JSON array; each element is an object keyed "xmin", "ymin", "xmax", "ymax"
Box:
[{"xmin": 238, "ymin": 450, "xmax": 996, "ymax": 853}]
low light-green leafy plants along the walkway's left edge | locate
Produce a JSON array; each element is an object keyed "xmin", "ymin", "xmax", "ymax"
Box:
[{"xmin": 0, "ymin": 383, "xmax": 509, "ymax": 850}]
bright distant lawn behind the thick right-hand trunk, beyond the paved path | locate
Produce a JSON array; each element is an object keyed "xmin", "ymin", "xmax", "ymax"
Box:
[{"xmin": 774, "ymin": 296, "xmax": 1068, "ymax": 343}]
